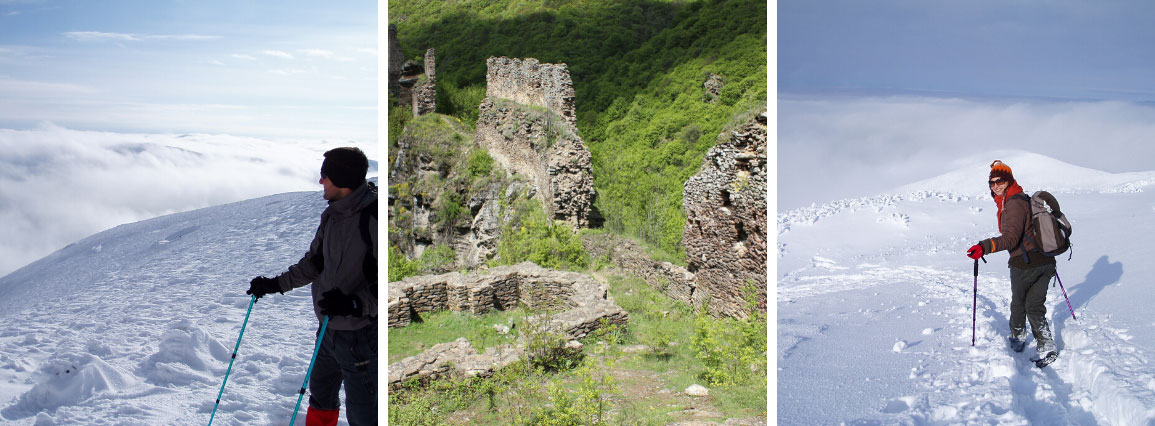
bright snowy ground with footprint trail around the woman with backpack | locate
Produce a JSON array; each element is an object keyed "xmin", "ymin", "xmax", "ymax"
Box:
[{"xmin": 777, "ymin": 152, "xmax": 1155, "ymax": 425}]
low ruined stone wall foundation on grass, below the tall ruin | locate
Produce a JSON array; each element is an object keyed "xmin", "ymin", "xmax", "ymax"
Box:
[{"xmin": 388, "ymin": 258, "xmax": 629, "ymax": 389}]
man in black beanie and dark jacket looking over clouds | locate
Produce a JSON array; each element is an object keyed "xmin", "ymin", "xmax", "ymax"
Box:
[{"xmin": 246, "ymin": 148, "xmax": 378, "ymax": 426}]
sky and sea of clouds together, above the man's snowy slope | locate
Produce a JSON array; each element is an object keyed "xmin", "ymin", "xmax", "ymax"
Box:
[{"xmin": 0, "ymin": 0, "xmax": 383, "ymax": 275}]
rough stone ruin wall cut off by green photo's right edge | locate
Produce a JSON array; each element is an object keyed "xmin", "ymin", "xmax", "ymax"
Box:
[{"xmin": 683, "ymin": 112, "xmax": 767, "ymax": 317}]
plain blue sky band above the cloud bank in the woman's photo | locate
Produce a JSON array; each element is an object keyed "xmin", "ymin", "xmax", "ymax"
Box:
[{"xmin": 777, "ymin": 0, "xmax": 1155, "ymax": 102}]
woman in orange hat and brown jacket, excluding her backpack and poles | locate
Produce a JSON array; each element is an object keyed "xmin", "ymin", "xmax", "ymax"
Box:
[{"xmin": 967, "ymin": 160, "xmax": 1058, "ymax": 366}]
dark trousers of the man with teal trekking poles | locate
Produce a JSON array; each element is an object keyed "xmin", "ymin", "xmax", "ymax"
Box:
[{"xmin": 308, "ymin": 322, "xmax": 378, "ymax": 426}]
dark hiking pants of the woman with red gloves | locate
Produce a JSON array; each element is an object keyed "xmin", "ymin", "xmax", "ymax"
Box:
[{"xmin": 1011, "ymin": 264, "xmax": 1056, "ymax": 357}]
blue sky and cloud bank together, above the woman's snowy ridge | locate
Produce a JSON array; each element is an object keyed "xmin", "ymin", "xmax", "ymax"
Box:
[{"xmin": 776, "ymin": 0, "xmax": 1155, "ymax": 210}]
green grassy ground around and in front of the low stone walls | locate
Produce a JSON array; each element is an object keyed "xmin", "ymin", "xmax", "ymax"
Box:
[{"xmin": 389, "ymin": 270, "xmax": 767, "ymax": 426}]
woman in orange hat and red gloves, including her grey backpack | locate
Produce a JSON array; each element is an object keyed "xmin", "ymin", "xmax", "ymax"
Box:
[{"xmin": 967, "ymin": 160, "xmax": 1074, "ymax": 368}]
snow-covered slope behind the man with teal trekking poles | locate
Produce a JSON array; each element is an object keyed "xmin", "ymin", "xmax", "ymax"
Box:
[{"xmin": 0, "ymin": 185, "xmax": 360, "ymax": 425}]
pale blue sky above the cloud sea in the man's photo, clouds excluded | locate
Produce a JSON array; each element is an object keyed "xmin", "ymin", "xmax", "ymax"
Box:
[{"xmin": 0, "ymin": 0, "xmax": 378, "ymax": 141}]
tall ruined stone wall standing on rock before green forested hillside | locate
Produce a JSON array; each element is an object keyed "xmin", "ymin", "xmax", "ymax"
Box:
[{"xmin": 474, "ymin": 58, "xmax": 594, "ymax": 227}]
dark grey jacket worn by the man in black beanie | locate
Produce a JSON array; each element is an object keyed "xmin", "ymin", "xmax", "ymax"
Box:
[{"xmin": 277, "ymin": 178, "xmax": 377, "ymax": 330}]
